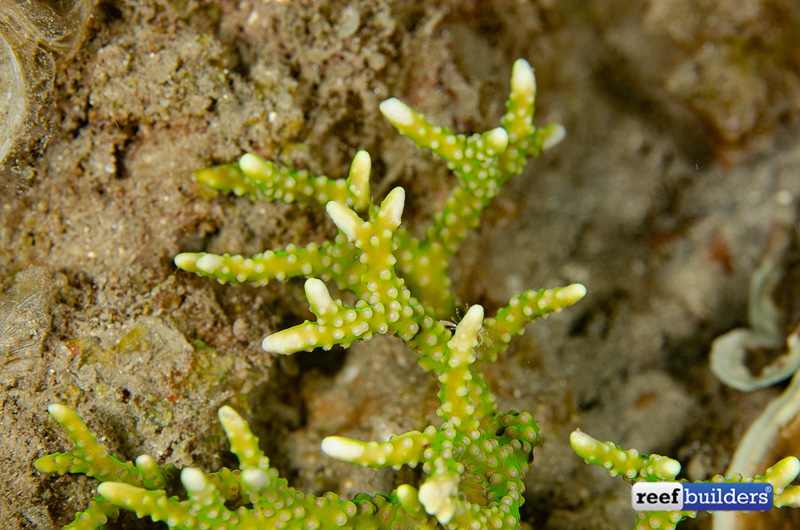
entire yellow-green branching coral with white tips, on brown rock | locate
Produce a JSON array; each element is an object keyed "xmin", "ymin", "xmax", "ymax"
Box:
[{"xmin": 36, "ymin": 59, "xmax": 800, "ymax": 530}]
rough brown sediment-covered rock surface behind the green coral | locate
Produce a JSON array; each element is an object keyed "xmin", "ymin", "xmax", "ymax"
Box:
[{"xmin": 0, "ymin": 0, "xmax": 800, "ymax": 529}]
